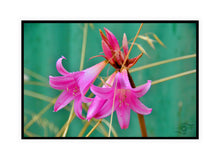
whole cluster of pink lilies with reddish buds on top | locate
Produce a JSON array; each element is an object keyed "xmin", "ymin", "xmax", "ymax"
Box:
[{"xmin": 49, "ymin": 28, "xmax": 152, "ymax": 129}]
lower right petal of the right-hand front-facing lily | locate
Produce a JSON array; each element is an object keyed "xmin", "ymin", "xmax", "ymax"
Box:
[{"xmin": 129, "ymin": 98, "xmax": 152, "ymax": 115}]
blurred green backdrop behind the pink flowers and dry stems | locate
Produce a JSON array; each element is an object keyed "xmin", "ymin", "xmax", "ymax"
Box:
[{"xmin": 23, "ymin": 22, "xmax": 197, "ymax": 137}]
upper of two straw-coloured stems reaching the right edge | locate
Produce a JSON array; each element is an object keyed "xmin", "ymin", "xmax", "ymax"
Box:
[{"xmin": 130, "ymin": 54, "xmax": 196, "ymax": 73}]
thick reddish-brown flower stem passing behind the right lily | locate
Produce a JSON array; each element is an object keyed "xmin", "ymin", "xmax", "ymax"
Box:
[{"xmin": 128, "ymin": 71, "xmax": 147, "ymax": 137}]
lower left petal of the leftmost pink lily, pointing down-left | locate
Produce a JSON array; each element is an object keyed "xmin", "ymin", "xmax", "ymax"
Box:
[{"xmin": 54, "ymin": 90, "xmax": 74, "ymax": 112}]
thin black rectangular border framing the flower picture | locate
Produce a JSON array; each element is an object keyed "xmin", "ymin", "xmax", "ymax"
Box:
[{"xmin": 21, "ymin": 20, "xmax": 199, "ymax": 140}]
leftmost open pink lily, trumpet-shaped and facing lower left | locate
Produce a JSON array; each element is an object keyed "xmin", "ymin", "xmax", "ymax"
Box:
[{"xmin": 49, "ymin": 56, "xmax": 106, "ymax": 119}]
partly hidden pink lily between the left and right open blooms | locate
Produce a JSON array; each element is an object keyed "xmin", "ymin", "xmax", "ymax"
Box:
[{"xmin": 86, "ymin": 72, "xmax": 117, "ymax": 120}]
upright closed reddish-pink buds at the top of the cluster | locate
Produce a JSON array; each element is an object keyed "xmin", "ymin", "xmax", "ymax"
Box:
[{"xmin": 100, "ymin": 28, "xmax": 142, "ymax": 69}]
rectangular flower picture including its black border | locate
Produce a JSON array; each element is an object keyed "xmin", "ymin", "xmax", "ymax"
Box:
[{"xmin": 21, "ymin": 21, "xmax": 199, "ymax": 139}]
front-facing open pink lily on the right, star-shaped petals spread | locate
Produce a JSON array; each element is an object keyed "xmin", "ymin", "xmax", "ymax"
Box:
[{"xmin": 90, "ymin": 69, "xmax": 152, "ymax": 129}]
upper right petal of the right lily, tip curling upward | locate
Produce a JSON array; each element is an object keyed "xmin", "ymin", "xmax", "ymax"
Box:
[{"xmin": 132, "ymin": 80, "xmax": 151, "ymax": 98}]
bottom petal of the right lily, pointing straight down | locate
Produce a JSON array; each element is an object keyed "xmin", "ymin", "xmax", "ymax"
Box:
[{"xmin": 116, "ymin": 103, "xmax": 130, "ymax": 129}]
